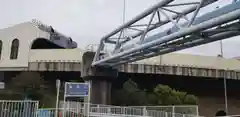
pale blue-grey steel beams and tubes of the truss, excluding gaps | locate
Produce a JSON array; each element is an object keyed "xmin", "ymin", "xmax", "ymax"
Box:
[{"xmin": 92, "ymin": 0, "xmax": 240, "ymax": 66}]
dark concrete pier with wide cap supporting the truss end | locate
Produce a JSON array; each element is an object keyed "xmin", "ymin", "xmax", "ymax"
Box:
[{"xmin": 81, "ymin": 52, "xmax": 118, "ymax": 104}]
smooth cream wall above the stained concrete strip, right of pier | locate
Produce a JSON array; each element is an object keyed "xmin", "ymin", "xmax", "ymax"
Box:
[{"xmin": 135, "ymin": 53, "xmax": 240, "ymax": 70}]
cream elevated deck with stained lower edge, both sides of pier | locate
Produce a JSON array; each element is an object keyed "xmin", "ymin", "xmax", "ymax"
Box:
[{"xmin": 27, "ymin": 49, "xmax": 240, "ymax": 79}]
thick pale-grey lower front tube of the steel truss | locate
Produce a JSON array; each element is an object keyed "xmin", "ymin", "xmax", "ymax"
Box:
[{"xmin": 92, "ymin": 2, "xmax": 240, "ymax": 65}]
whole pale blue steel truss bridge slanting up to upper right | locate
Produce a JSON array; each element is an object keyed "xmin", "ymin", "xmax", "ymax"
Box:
[{"xmin": 92, "ymin": 0, "xmax": 240, "ymax": 67}]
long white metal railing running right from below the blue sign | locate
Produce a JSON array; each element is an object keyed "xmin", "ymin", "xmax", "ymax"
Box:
[{"xmin": 60, "ymin": 101, "xmax": 201, "ymax": 117}]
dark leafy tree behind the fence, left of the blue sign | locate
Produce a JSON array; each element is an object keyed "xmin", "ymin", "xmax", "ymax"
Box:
[{"xmin": 6, "ymin": 72, "xmax": 55, "ymax": 105}]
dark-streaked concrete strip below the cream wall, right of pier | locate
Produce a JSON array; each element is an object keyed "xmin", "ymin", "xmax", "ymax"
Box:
[{"xmin": 118, "ymin": 63, "xmax": 240, "ymax": 79}]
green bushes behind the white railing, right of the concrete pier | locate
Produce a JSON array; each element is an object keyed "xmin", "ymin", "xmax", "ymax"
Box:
[{"xmin": 113, "ymin": 80, "xmax": 198, "ymax": 106}]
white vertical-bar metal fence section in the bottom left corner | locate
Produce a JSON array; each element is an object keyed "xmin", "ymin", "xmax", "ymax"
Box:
[{"xmin": 0, "ymin": 100, "xmax": 38, "ymax": 117}]
